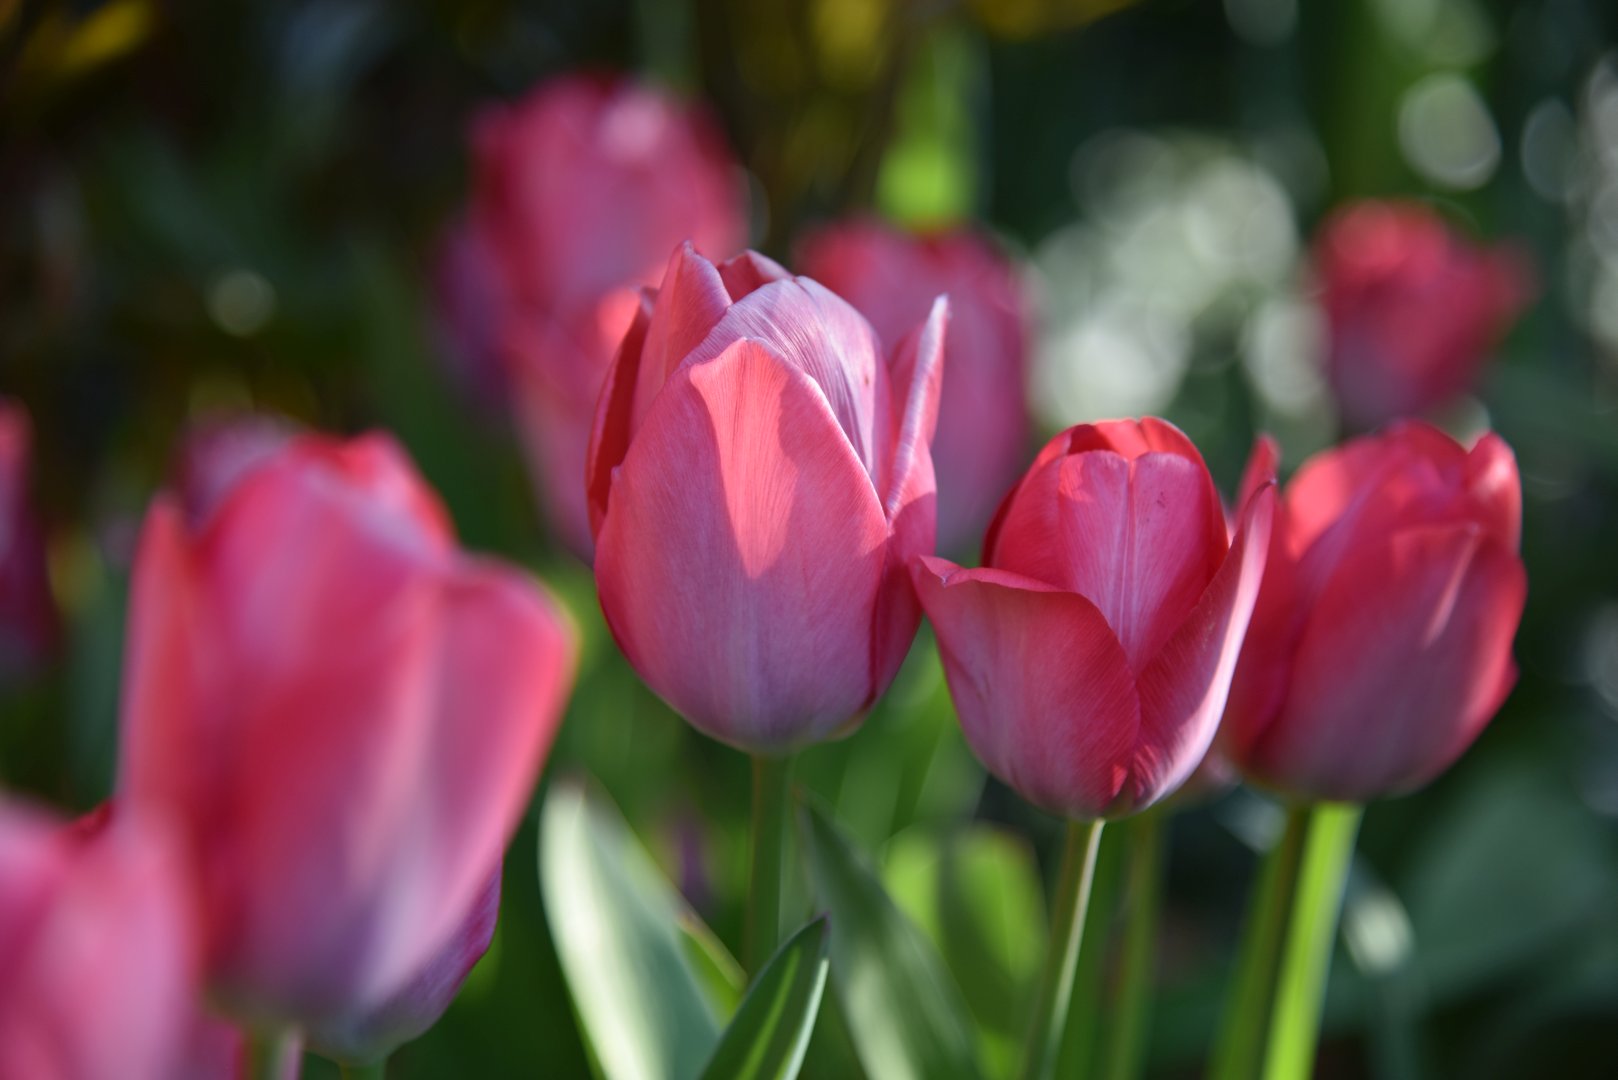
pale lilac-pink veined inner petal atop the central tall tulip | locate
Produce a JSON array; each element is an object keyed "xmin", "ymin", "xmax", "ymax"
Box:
[{"xmin": 684, "ymin": 277, "xmax": 893, "ymax": 484}]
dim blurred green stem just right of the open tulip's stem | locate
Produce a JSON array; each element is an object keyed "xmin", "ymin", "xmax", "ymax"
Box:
[{"xmin": 1102, "ymin": 810, "xmax": 1163, "ymax": 1080}]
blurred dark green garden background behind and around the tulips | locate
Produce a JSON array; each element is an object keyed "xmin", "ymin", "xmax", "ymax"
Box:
[{"xmin": 0, "ymin": 0, "xmax": 1618, "ymax": 1078}]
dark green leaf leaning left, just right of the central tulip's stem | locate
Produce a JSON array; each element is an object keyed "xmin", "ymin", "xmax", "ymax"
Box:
[{"xmin": 801, "ymin": 806, "xmax": 982, "ymax": 1080}]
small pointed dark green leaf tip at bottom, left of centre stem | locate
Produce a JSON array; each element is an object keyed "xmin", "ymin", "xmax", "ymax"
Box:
[{"xmin": 702, "ymin": 916, "xmax": 827, "ymax": 1080}]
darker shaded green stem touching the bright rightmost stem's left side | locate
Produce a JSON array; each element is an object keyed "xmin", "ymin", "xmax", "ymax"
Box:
[{"xmin": 1207, "ymin": 806, "xmax": 1309, "ymax": 1080}]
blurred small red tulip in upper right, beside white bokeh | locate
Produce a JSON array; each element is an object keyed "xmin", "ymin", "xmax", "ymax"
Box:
[{"xmin": 1314, "ymin": 202, "xmax": 1532, "ymax": 427}]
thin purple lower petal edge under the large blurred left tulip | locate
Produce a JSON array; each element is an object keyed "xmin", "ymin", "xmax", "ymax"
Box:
[{"xmin": 307, "ymin": 870, "xmax": 500, "ymax": 1064}]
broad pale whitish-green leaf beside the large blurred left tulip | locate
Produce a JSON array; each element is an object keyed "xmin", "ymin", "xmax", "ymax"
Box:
[{"xmin": 539, "ymin": 780, "xmax": 735, "ymax": 1080}]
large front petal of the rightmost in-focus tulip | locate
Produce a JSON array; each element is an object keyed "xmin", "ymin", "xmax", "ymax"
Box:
[{"xmin": 1247, "ymin": 523, "xmax": 1527, "ymax": 801}]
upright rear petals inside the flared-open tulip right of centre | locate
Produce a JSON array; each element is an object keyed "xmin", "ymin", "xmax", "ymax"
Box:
[{"xmin": 993, "ymin": 450, "xmax": 1226, "ymax": 670}]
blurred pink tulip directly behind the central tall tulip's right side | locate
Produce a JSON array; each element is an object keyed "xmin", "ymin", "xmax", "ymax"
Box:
[{"xmin": 799, "ymin": 222, "xmax": 1029, "ymax": 551}]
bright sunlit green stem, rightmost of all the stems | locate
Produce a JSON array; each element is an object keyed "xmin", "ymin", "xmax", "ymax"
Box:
[{"xmin": 1264, "ymin": 803, "xmax": 1364, "ymax": 1080}]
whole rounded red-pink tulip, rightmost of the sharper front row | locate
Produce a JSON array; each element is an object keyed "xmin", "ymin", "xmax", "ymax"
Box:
[{"xmin": 1222, "ymin": 423, "xmax": 1527, "ymax": 801}]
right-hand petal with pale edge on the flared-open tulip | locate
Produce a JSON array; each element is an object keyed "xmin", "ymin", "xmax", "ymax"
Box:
[{"xmin": 1129, "ymin": 484, "xmax": 1275, "ymax": 810}]
